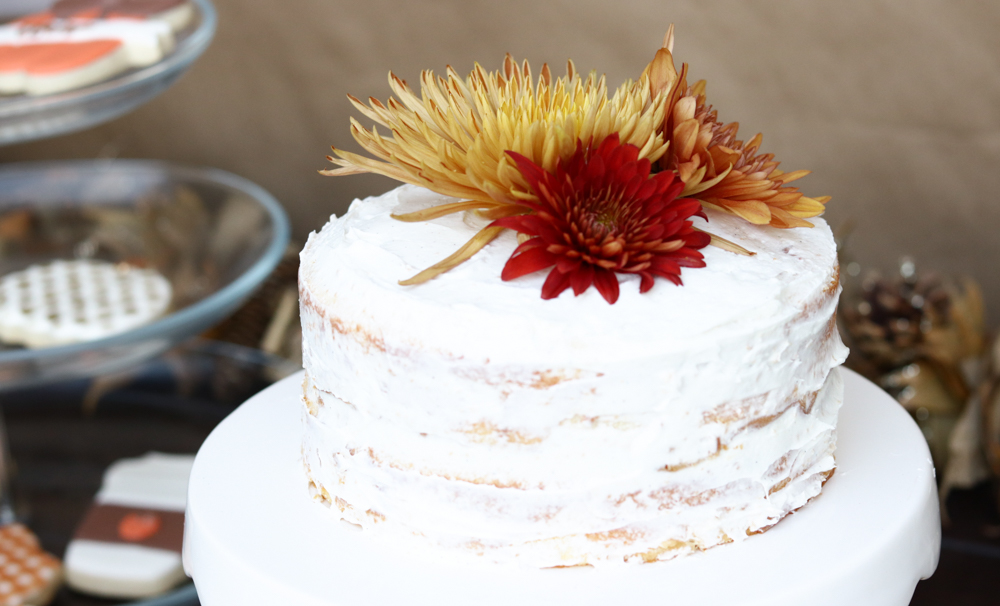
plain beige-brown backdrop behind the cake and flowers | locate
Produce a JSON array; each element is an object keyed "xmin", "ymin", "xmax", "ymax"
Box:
[{"xmin": 0, "ymin": 0, "xmax": 1000, "ymax": 325}]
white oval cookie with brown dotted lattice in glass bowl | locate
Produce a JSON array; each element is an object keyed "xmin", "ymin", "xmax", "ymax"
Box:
[{"xmin": 0, "ymin": 260, "xmax": 172, "ymax": 350}]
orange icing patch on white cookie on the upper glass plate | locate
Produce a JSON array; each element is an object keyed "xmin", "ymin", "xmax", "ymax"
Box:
[{"xmin": 0, "ymin": 40, "xmax": 122, "ymax": 75}]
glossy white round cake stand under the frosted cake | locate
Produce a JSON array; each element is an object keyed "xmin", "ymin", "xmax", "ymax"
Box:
[{"xmin": 184, "ymin": 371, "xmax": 941, "ymax": 606}]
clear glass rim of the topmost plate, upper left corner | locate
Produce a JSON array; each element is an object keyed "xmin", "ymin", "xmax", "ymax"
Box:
[{"xmin": 0, "ymin": 0, "xmax": 216, "ymax": 145}]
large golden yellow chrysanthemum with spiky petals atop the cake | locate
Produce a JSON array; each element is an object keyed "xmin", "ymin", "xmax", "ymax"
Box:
[{"xmin": 322, "ymin": 55, "xmax": 667, "ymax": 284}]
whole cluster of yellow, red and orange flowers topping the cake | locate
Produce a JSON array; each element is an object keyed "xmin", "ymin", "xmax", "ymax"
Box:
[{"xmin": 321, "ymin": 25, "xmax": 829, "ymax": 303}]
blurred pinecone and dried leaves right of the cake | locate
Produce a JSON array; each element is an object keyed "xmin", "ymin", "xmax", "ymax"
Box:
[{"xmin": 838, "ymin": 257, "xmax": 1000, "ymax": 486}]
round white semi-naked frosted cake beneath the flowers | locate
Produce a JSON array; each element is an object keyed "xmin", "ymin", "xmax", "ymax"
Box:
[{"xmin": 300, "ymin": 186, "xmax": 846, "ymax": 566}]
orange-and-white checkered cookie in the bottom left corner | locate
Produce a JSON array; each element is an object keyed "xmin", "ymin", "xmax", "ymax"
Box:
[{"xmin": 0, "ymin": 524, "xmax": 62, "ymax": 606}]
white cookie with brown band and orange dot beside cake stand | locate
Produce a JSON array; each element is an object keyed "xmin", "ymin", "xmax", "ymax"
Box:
[{"xmin": 65, "ymin": 453, "xmax": 194, "ymax": 604}]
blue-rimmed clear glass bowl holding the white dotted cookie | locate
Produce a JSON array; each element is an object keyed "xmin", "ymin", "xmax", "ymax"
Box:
[{"xmin": 0, "ymin": 160, "xmax": 289, "ymax": 392}]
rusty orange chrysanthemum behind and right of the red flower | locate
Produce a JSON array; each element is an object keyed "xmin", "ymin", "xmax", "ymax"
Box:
[{"xmin": 643, "ymin": 25, "xmax": 830, "ymax": 228}]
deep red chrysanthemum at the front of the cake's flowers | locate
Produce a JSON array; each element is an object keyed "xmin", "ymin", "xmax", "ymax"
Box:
[{"xmin": 492, "ymin": 135, "xmax": 711, "ymax": 303}]
